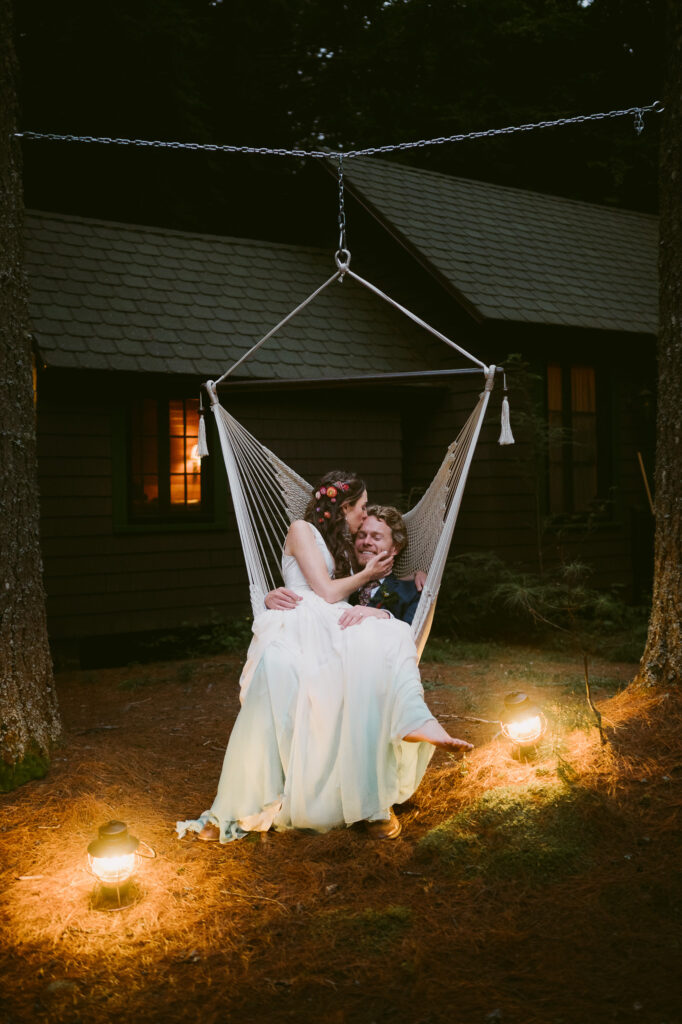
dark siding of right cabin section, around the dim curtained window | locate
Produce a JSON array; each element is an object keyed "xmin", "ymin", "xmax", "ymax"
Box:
[{"xmin": 404, "ymin": 331, "xmax": 655, "ymax": 601}]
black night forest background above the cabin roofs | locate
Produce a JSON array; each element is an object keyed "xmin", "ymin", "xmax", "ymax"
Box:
[{"xmin": 17, "ymin": 0, "xmax": 660, "ymax": 246}]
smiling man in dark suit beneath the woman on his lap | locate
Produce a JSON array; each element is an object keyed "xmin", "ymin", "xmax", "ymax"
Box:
[{"xmin": 265, "ymin": 505, "xmax": 423, "ymax": 629}]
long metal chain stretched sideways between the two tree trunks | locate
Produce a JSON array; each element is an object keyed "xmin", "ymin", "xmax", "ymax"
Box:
[{"xmin": 14, "ymin": 99, "xmax": 664, "ymax": 158}]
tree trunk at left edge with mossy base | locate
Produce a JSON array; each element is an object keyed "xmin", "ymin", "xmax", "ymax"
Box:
[{"xmin": 0, "ymin": 0, "xmax": 60, "ymax": 792}]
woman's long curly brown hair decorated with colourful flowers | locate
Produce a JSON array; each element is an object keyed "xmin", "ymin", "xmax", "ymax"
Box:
[{"xmin": 303, "ymin": 469, "xmax": 367, "ymax": 580}]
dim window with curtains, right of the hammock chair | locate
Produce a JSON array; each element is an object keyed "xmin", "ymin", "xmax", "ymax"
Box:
[{"xmin": 547, "ymin": 364, "xmax": 599, "ymax": 514}]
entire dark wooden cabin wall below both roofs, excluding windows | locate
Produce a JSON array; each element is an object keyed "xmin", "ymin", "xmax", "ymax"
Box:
[{"xmin": 38, "ymin": 335, "xmax": 653, "ymax": 663}]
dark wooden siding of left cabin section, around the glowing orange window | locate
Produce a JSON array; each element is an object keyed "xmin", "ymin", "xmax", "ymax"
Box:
[{"xmin": 38, "ymin": 374, "xmax": 402, "ymax": 641}]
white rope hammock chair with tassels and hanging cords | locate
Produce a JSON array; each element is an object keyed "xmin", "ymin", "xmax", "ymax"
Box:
[{"xmin": 199, "ymin": 250, "xmax": 513, "ymax": 655}]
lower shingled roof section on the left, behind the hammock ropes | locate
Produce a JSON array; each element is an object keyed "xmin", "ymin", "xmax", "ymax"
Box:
[{"xmin": 26, "ymin": 212, "xmax": 453, "ymax": 379}]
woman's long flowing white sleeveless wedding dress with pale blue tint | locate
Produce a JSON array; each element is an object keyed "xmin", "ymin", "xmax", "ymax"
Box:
[{"xmin": 177, "ymin": 524, "xmax": 434, "ymax": 843}]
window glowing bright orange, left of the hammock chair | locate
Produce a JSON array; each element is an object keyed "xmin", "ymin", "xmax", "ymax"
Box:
[{"xmin": 130, "ymin": 398, "xmax": 208, "ymax": 520}]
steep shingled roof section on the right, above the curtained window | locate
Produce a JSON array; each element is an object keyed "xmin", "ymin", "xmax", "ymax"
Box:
[{"xmin": 345, "ymin": 158, "xmax": 657, "ymax": 334}]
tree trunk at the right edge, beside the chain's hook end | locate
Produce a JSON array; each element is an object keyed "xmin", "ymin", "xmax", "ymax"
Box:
[{"xmin": 637, "ymin": 0, "xmax": 682, "ymax": 686}]
